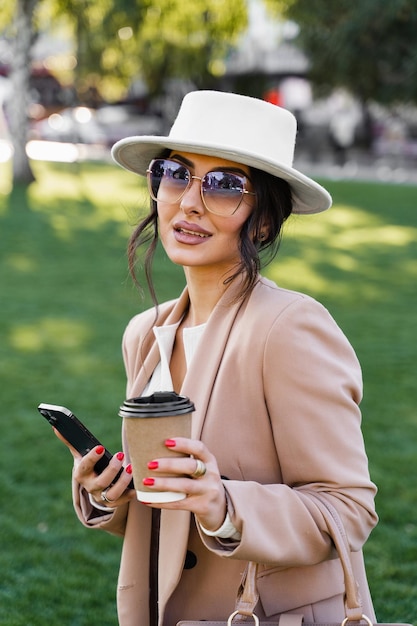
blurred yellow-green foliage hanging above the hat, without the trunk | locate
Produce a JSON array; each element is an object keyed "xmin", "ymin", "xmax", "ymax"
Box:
[{"xmin": 35, "ymin": 0, "xmax": 247, "ymax": 99}]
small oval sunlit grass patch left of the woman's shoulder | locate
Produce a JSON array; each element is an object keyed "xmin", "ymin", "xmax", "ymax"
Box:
[{"xmin": 10, "ymin": 317, "xmax": 90, "ymax": 352}]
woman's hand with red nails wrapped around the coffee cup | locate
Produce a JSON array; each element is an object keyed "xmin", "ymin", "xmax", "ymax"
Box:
[{"xmin": 144, "ymin": 437, "xmax": 227, "ymax": 531}]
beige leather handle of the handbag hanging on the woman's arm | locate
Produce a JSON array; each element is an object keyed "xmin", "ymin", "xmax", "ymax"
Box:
[{"xmin": 234, "ymin": 494, "xmax": 369, "ymax": 622}]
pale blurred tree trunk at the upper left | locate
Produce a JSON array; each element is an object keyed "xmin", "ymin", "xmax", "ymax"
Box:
[{"xmin": 8, "ymin": 0, "xmax": 38, "ymax": 184}]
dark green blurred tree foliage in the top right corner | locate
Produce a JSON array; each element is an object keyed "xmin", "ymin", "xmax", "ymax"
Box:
[{"xmin": 265, "ymin": 0, "xmax": 417, "ymax": 104}]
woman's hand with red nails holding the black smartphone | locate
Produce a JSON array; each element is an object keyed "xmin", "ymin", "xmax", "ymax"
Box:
[{"xmin": 54, "ymin": 429, "xmax": 135, "ymax": 508}]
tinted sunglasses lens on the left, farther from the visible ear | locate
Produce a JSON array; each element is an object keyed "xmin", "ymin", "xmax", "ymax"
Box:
[{"xmin": 148, "ymin": 159, "xmax": 190, "ymax": 202}]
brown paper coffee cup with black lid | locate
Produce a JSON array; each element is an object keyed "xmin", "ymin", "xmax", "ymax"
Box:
[{"xmin": 119, "ymin": 391, "xmax": 194, "ymax": 502}]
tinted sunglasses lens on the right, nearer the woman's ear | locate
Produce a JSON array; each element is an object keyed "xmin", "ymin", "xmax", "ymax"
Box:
[{"xmin": 202, "ymin": 171, "xmax": 245, "ymax": 215}]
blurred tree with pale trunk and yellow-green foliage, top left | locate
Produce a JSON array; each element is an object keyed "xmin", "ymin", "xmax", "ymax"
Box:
[{"xmin": 0, "ymin": 0, "xmax": 247, "ymax": 182}]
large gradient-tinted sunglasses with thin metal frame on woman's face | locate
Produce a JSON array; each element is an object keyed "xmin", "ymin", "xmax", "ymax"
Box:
[{"xmin": 146, "ymin": 159, "xmax": 256, "ymax": 217}]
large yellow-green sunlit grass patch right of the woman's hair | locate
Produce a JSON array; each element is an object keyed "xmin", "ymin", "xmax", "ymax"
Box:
[{"xmin": 265, "ymin": 203, "xmax": 417, "ymax": 299}]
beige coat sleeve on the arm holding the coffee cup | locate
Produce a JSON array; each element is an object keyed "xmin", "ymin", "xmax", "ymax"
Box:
[{"xmin": 201, "ymin": 297, "xmax": 377, "ymax": 568}]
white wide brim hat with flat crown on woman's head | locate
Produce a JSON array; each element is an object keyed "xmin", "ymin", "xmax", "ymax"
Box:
[{"xmin": 112, "ymin": 91, "xmax": 332, "ymax": 213}]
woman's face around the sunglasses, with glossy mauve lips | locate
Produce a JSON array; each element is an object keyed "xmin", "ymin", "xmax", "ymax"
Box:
[{"xmin": 158, "ymin": 151, "xmax": 255, "ymax": 275}]
